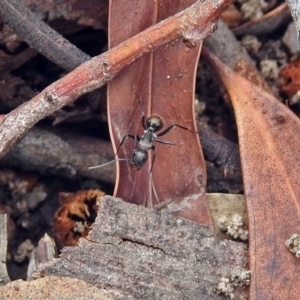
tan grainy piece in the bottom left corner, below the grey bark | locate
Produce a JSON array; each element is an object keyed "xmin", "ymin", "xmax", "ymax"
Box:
[{"xmin": 0, "ymin": 276, "xmax": 115, "ymax": 300}]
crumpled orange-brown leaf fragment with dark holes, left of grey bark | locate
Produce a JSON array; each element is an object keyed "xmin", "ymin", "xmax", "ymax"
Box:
[{"xmin": 53, "ymin": 190, "xmax": 105, "ymax": 246}]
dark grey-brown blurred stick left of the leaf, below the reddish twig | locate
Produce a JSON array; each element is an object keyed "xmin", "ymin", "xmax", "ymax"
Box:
[{"xmin": 0, "ymin": 128, "xmax": 115, "ymax": 183}]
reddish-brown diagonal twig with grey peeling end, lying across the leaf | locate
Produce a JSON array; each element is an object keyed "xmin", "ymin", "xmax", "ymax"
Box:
[{"xmin": 0, "ymin": 0, "xmax": 233, "ymax": 157}]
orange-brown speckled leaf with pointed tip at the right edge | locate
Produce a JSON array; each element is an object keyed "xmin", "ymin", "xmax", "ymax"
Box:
[{"xmin": 205, "ymin": 51, "xmax": 300, "ymax": 300}]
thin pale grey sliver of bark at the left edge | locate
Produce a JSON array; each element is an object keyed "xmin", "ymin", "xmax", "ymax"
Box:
[{"xmin": 0, "ymin": 214, "xmax": 10, "ymax": 284}]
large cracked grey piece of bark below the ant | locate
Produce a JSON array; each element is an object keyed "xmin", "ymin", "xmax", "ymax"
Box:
[{"xmin": 35, "ymin": 196, "xmax": 247, "ymax": 300}]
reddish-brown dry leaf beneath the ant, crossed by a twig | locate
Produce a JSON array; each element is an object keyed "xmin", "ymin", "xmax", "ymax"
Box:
[{"xmin": 108, "ymin": 0, "xmax": 211, "ymax": 225}]
